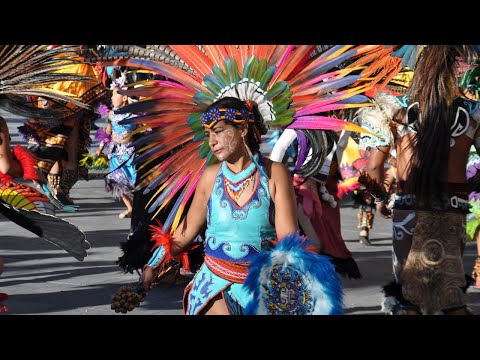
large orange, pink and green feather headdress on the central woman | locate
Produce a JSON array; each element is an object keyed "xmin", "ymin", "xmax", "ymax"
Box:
[{"xmin": 104, "ymin": 45, "xmax": 400, "ymax": 231}]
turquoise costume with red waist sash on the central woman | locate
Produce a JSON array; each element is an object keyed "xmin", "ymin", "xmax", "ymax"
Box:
[{"xmin": 184, "ymin": 155, "xmax": 277, "ymax": 315}]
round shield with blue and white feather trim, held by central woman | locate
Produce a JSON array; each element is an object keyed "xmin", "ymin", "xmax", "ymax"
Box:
[{"xmin": 244, "ymin": 234, "xmax": 343, "ymax": 315}]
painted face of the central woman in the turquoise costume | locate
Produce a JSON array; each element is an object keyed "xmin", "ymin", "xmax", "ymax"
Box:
[{"xmin": 205, "ymin": 121, "xmax": 242, "ymax": 161}]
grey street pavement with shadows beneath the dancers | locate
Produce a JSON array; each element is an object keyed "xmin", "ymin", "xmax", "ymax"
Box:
[{"xmin": 0, "ymin": 113, "xmax": 480, "ymax": 316}]
